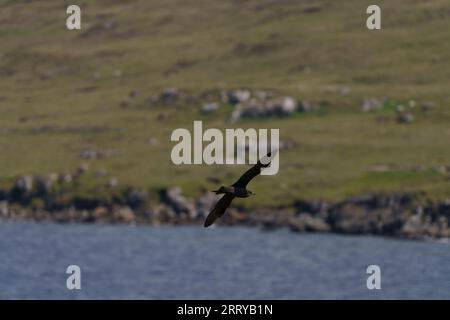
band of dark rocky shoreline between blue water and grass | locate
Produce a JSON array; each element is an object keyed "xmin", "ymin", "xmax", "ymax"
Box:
[{"xmin": 0, "ymin": 170, "xmax": 450, "ymax": 239}]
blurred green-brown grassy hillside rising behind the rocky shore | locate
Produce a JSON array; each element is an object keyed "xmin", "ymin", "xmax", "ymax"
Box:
[{"xmin": 0, "ymin": 0, "xmax": 450, "ymax": 205}]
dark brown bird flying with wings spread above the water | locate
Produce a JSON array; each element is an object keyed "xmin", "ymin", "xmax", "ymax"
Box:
[{"xmin": 205, "ymin": 152, "xmax": 272, "ymax": 228}]
